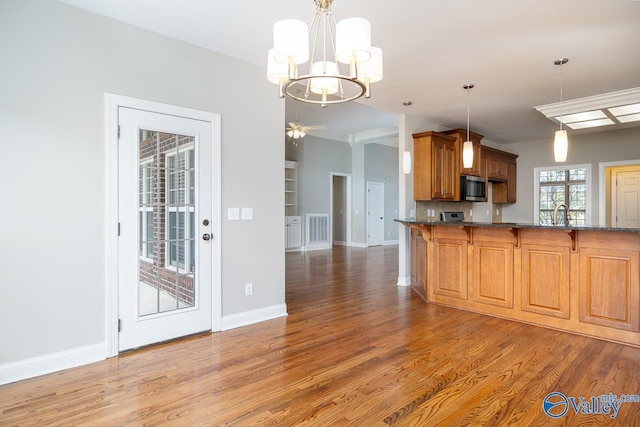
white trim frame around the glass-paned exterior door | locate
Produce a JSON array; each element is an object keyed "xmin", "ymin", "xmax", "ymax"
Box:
[{"xmin": 104, "ymin": 92, "xmax": 222, "ymax": 357}]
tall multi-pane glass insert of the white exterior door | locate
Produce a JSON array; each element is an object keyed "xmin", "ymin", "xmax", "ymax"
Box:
[{"xmin": 138, "ymin": 129, "xmax": 196, "ymax": 316}]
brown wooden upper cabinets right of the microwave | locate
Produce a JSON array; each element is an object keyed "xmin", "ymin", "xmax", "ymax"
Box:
[{"xmin": 482, "ymin": 146, "xmax": 518, "ymax": 203}]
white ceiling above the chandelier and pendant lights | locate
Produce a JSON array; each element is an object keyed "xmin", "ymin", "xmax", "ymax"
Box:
[{"xmin": 62, "ymin": 0, "xmax": 640, "ymax": 143}]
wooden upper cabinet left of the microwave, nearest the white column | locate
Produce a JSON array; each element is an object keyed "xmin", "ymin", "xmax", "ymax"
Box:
[{"xmin": 413, "ymin": 131, "xmax": 460, "ymax": 201}]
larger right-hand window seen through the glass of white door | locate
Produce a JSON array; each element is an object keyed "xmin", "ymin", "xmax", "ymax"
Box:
[{"xmin": 165, "ymin": 146, "xmax": 195, "ymax": 273}]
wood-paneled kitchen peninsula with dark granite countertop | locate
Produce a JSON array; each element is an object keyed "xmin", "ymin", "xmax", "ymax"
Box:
[{"xmin": 396, "ymin": 219, "xmax": 640, "ymax": 347}]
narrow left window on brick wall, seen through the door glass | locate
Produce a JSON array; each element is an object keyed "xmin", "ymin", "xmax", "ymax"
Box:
[{"xmin": 138, "ymin": 159, "xmax": 154, "ymax": 261}]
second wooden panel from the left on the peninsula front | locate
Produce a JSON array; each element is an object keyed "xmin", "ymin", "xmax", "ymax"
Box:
[{"xmin": 473, "ymin": 242, "xmax": 513, "ymax": 308}]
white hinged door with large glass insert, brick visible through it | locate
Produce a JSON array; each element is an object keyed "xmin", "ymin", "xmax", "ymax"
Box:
[{"xmin": 118, "ymin": 107, "xmax": 218, "ymax": 351}]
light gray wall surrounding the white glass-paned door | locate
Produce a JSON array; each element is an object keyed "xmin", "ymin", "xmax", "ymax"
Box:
[{"xmin": 0, "ymin": 0, "xmax": 285, "ymax": 374}]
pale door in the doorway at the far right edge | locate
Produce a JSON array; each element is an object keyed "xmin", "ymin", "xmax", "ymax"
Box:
[{"xmin": 612, "ymin": 169, "xmax": 640, "ymax": 228}]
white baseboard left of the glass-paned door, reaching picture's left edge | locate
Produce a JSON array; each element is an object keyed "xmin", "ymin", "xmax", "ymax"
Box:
[{"xmin": 0, "ymin": 343, "xmax": 107, "ymax": 385}]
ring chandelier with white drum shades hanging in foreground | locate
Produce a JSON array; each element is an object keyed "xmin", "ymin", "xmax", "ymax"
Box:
[{"xmin": 267, "ymin": 0, "xmax": 382, "ymax": 107}]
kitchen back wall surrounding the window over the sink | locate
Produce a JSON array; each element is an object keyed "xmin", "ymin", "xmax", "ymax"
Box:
[{"xmin": 500, "ymin": 127, "xmax": 640, "ymax": 225}]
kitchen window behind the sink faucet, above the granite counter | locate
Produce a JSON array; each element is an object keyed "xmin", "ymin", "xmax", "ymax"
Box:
[{"xmin": 534, "ymin": 165, "xmax": 591, "ymax": 225}]
